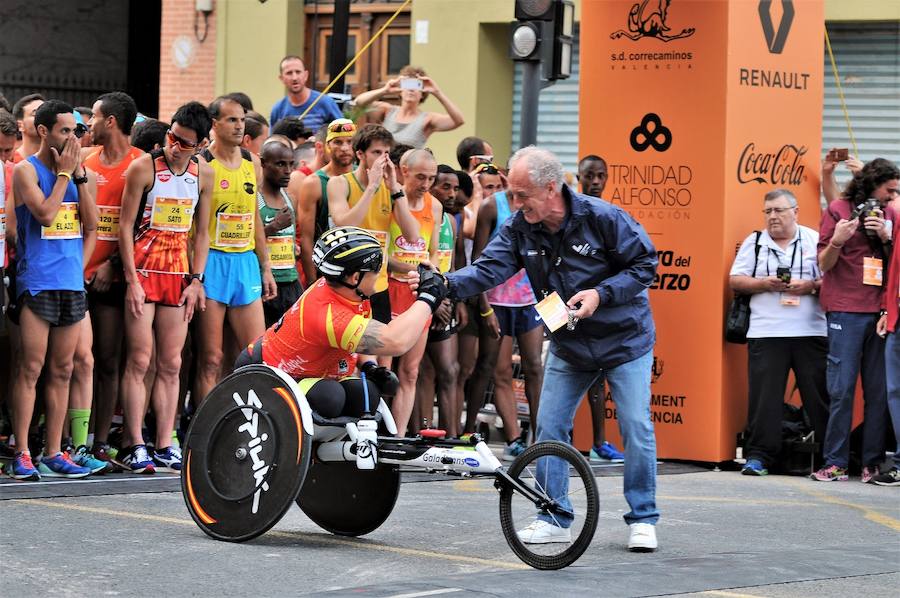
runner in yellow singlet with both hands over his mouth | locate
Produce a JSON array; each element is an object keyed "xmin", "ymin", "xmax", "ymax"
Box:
[{"xmin": 327, "ymin": 125, "xmax": 419, "ymax": 323}]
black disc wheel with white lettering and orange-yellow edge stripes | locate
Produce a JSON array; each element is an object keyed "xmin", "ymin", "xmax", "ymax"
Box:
[{"xmin": 181, "ymin": 365, "xmax": 312, "ymax": 542}]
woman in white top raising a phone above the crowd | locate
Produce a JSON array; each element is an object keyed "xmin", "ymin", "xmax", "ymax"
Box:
[{"xmin": 356, "ymin": 66, "xmax": 464, "ymax": 149}]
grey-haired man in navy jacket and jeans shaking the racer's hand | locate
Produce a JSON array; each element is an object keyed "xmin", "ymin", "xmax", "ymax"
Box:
[{"xmin": 447, "ymin": 146, "xmax": 659, "ymax": 552}]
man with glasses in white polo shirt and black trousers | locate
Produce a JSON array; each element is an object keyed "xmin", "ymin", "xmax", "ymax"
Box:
[{"xmin": 730, "ymin": 189, "xmax": 828, "ymax": 476}]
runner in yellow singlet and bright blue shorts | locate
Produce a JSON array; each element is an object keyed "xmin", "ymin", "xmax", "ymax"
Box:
[{"xmin": 192, "ymin": 97, "xmax": 277, "ymax": 410}]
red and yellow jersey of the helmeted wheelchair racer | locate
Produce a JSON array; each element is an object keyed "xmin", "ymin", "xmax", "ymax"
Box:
[{"xmin": 262, "ymin": 278, "xmax": 372, "ymax": 380}]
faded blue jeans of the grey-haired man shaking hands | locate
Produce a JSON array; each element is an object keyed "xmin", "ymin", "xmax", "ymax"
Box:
[{"xmin": 536, "ymin": 351, "xmax": 659, "ymax": 527}]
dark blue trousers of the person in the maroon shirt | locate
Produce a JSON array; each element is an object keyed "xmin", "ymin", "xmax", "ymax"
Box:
[{"xmin": 824, "ymin": 312, "xmax": 887, "ymax": 468}]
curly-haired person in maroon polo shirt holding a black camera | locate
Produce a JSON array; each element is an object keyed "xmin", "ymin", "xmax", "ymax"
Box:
[{"xmin": 813, "ymin": 158, "xmax": 900, "ymax": 483}]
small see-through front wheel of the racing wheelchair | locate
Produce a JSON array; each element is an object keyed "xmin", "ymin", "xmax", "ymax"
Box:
[{"xmin": 496, "ymin": 441, "xmax": 600, "ymax": 569}]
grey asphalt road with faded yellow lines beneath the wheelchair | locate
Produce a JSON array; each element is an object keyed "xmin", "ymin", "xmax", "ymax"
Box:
[{"xmin": 0, "ymin": 471, "xmax": 900, "ymax": 598}]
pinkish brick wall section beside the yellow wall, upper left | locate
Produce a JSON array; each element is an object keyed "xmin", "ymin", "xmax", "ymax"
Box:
[{"xmin": 159, "ymin": 0, "xmax": 216, "ymax": 122}]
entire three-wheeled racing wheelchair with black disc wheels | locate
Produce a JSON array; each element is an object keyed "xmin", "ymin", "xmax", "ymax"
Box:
[{"xmin": 181, "ymin": 365, "xmax": 599, "ymax": 569}]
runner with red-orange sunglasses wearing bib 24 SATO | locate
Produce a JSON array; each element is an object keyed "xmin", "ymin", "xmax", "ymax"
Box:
[{"xmin": 119, "ymin": 102, "xmax": 213, "ymax": 473}]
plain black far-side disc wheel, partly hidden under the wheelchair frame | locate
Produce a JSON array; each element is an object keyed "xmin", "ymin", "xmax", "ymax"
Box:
[{"xmin": 297, "ymin": 461, "xmax": 400, "ymax": 536}]
